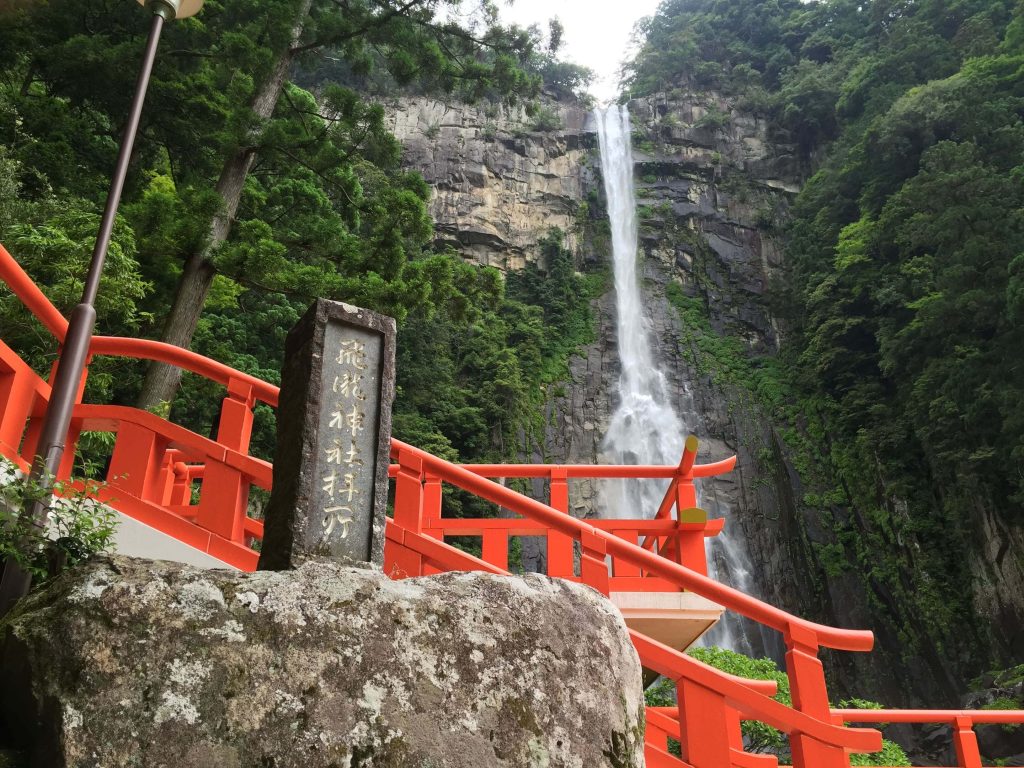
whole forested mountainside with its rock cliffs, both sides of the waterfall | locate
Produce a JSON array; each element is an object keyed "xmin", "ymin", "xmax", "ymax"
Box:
[{"xmin": 0, "ymin": 0, "xmax": 1024, "ymax": 729}]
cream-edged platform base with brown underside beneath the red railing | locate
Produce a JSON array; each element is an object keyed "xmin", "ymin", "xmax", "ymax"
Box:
[{"xmin": 609, "ymin": 592, "xmax": 723, "ymax": 650}]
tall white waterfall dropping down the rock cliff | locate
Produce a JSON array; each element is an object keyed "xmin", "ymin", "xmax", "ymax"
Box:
[{"xmin": 594, "ymin": 104, "xmax": 754, "ymax": 654}]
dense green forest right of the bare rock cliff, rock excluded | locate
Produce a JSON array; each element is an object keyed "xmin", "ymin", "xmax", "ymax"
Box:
[{"xmin": 625, "ymin": 0, "xmax": 1024, "ymax": 692}]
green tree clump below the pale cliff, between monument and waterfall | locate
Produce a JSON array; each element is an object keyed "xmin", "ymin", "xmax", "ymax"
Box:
[{"xmin": 394, "ymin": 229, "xmax": 603, "ymax": 468}]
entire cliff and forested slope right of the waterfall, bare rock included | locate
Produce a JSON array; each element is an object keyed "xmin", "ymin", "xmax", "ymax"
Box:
[{"xmin": 628, "ymin": 0, "xmax": 1024, "ymax": 705}]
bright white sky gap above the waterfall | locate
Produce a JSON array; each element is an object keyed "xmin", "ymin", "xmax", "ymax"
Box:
[{"xmin": 497, "ymin": 0, "xmax": 658, "ymax": 101}]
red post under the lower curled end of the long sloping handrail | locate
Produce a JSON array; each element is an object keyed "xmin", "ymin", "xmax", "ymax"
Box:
[{"xmin": 785, "ymin": 625, "xmax": 850, "ymax": 768}]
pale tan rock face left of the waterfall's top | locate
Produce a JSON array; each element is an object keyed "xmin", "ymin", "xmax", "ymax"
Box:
[{"xmin": 386, "ymin": 98, "xmax": 592, "ymax": 269}]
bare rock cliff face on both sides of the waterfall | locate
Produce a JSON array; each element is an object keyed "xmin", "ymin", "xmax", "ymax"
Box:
[{"xmin": 389, "ymin": 94, "xmax": 847, "ymax": 671}]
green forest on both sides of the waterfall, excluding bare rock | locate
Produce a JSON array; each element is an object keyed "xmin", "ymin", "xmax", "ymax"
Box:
[{"xmin": 0, "ymin": 0, "xmax": 1024, "ymax": 716}]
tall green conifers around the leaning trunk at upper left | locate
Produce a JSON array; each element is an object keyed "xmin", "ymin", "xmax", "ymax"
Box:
[{"xmin": 0, "ymin": 0, "xmax": 552, "ymax": 406}]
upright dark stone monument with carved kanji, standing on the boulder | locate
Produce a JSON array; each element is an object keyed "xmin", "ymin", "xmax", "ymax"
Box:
[{"xmin": 259, "ymin": 299, "xmax": 395, "ymax": 570}]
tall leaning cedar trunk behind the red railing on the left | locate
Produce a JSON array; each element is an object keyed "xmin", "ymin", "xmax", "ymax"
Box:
[{"xmin": 138, "ymin": 0, "xmax": 312, "ymax": 409}]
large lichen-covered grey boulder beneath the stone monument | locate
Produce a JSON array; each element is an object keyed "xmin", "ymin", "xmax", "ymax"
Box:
[{"xmin": 0, "ymin": 558, "xmax": 643, "ymax": 768}]
